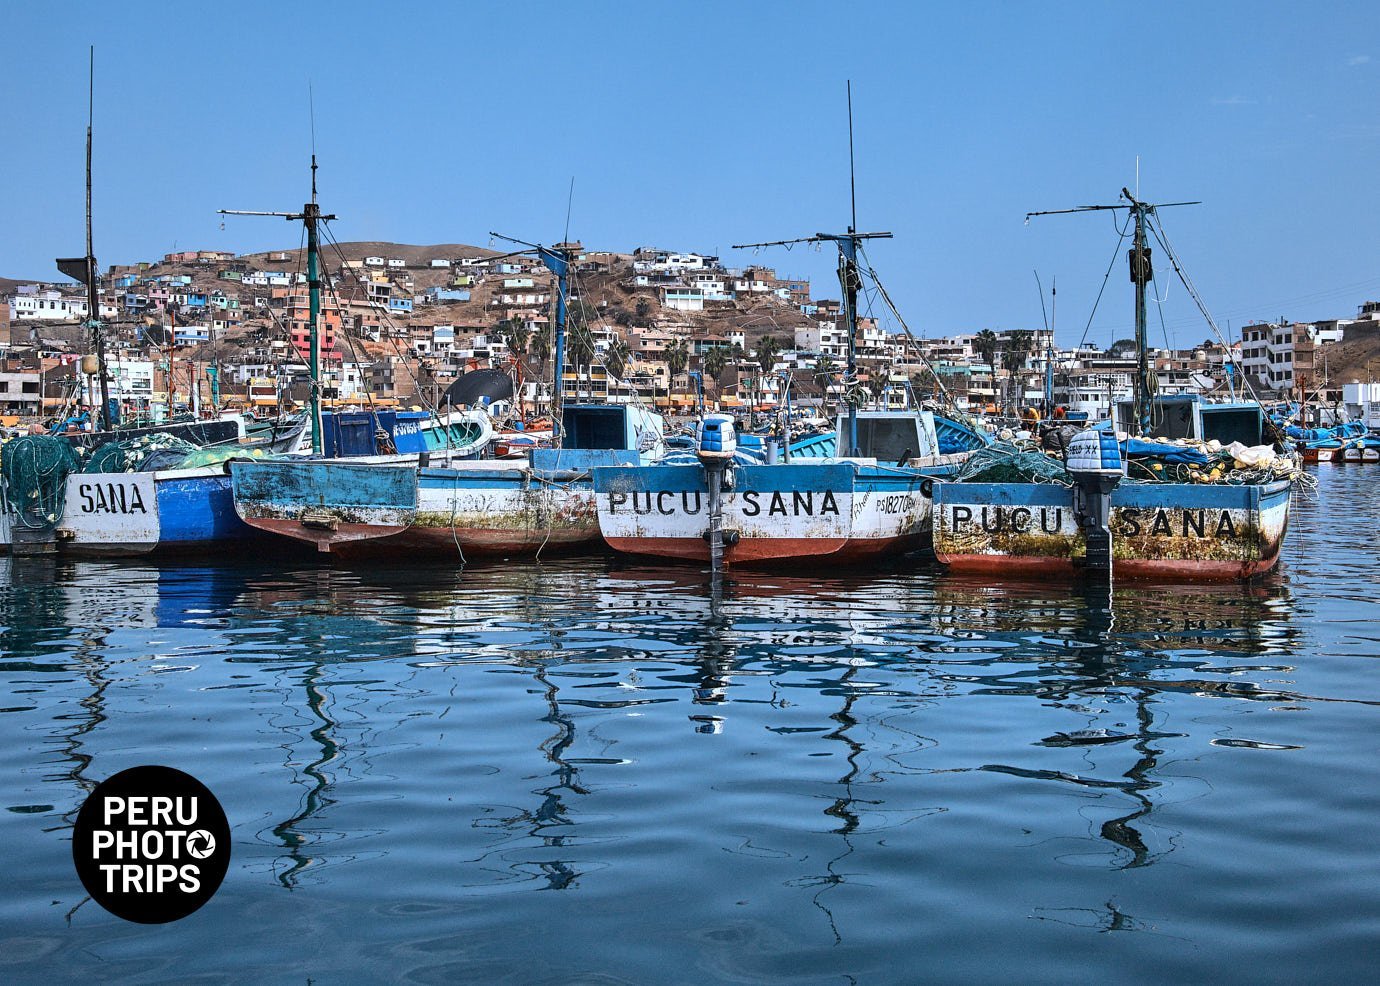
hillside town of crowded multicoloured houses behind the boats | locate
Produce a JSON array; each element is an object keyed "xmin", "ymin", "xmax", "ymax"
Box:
[{"xmin": 0, "ymin": 243, "xmax": 1380, "ymax": 418}]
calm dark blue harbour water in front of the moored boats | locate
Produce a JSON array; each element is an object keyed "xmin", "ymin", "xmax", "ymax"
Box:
[{"xmin": 0, "ymin": 465, "xmax": 1380, "ymax": 983}]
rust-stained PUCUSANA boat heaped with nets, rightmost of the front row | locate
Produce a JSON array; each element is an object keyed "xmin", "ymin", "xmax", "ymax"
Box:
[{"xmin": 934, "ymin": 189, "xmax": 1296, "ymax": 580}]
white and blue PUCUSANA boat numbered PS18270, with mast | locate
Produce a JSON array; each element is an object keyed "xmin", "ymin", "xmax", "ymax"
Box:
[{"xmin": 595, "ymin": 91, "xmax": 980, "ymax": 572}]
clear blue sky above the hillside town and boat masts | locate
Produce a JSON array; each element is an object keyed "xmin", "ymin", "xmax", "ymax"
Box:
[{"xmin": 0, "ymin": 0, "xmax": 1380, "ymax": 345}]
